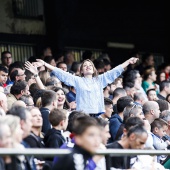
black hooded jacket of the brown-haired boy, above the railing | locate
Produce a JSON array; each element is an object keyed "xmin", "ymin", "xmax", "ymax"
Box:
[{"xmin": 44, "ymin": 128, "xmax": 65, "ymax": 148}]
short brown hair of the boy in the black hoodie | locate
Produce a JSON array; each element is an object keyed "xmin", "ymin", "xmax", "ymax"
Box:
[{"xmin": 49, "ymin": 108, "xmax": 67, "ymax": 126}]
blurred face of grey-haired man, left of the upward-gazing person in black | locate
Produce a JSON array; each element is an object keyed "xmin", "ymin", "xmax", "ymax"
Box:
[{"xmin": 21, "ymin": 111, "xmax": 32, "ymax": 139}]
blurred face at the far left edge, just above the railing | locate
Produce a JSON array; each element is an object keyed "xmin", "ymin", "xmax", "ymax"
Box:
[{"xmin": 0, "ymin": 124, "xmax": 12, "ymax": 148}]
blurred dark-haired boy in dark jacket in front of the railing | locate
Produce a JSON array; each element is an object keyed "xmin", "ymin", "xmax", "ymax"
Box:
[{"xmin": 52, "ymin": 116, "xmax": 101, "ymax": 170}]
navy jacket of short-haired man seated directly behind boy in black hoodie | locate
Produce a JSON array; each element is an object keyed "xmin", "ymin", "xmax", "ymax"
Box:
[{"xmin": 40, "ymin": 107, "xmax": 51, "ymax": 134}]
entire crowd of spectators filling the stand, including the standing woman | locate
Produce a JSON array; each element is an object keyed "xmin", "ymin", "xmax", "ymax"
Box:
[{"xmin": 0, "ymin": 48, "xmax": 170, "ymax": 170}]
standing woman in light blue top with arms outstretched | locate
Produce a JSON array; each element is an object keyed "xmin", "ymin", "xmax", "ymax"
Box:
[{"xmin": 25, "ymin": 57, "xmax": 138, "ymax": 116}]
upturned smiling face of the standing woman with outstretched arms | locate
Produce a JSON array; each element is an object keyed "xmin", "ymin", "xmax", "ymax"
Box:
[{"xmin": 81, "ymin": 61, "xmax": 94, "ymax": 76}]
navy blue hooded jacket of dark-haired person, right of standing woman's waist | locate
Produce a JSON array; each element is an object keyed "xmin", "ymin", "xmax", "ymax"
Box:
[{"xmin": 109, "ymin": 114, "xmax": 123, "ymax": 143}]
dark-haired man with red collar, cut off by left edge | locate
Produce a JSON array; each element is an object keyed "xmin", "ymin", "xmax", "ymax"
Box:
[{"xmin": 0, "ymin": 65, "xmax": 8, "ymax": 87}]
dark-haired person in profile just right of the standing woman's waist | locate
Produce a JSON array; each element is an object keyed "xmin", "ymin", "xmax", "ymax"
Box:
[{"xmin": 99, "ymin": 97, "xmax": 113, "ymax": 121}]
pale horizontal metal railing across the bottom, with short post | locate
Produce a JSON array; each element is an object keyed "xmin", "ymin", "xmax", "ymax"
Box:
[{"xmin": 0, "ymin": 148, "xmax": 170, "ymax": 170}]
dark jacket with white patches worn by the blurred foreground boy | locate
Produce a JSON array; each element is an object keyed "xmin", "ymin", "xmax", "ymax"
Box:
[{"xmin": 52, "ymin": 144, "xmax": 96, "ymax": 170}]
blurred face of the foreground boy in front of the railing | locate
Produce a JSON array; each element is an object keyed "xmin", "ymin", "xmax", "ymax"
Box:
[{"xmin": 75, "ymin": 126, "xmax": 101, "ymax": 153}]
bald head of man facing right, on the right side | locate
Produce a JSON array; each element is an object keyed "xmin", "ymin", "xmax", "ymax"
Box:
[{"xmin": 143, "ymin": 101, "xmax": 160, "ymax": 123}]
